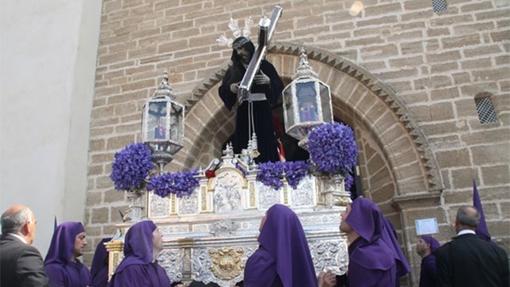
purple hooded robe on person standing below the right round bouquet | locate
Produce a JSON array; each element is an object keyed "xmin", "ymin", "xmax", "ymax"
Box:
[{"xmin": 346, "ymin": 198, "xmax": 409, "ymax": 287}]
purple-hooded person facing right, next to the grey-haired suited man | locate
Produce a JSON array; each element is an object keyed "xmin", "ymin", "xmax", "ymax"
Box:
[{"xmin": 44, "ymin": 221, "xmax": 90, "ymax": 287}]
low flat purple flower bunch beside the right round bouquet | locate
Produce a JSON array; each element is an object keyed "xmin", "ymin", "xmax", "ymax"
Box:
[{"xmin": 257, "ymin": 161, "xmax": 309, "ymax": 190}]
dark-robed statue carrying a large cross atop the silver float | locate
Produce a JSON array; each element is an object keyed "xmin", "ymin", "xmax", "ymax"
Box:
[{"xmin": 219, "ymin": 6, "xmax": 283, "ymax": 163}]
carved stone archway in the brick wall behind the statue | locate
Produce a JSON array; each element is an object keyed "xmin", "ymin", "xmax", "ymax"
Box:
[{"xmin": 170, "ymin": 43, "xmax": 442, "ymax": 284}]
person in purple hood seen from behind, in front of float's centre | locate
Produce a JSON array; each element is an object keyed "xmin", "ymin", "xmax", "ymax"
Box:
[{"xmin": 244, "ymin": 204, "xmax": 317, "ymax": 287}]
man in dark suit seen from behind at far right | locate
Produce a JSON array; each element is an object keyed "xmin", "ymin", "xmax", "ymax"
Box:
[{"xmin": 434, "ymin": 206, "xmax": 510, "ymax": 287}]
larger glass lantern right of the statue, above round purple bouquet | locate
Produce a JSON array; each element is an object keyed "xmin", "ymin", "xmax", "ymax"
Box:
[{"xmin": 283, "ymin": 48, "xmax": 333, "ymax": 147}]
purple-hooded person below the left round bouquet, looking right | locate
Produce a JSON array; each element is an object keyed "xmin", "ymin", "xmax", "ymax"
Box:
[{"xmin": 108, "ymin": 220, "xmax": 171, "ymax": 287}]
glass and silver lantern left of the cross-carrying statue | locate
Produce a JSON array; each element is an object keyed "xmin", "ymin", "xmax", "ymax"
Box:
[{"xmin": 142, "ymin": 72, "xmax": 184, "ymax": 165}]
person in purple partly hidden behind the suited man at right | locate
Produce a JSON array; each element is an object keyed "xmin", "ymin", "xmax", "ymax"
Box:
[{"xmin": 416, "ymin": 235, "xmax": 440, "ymax": 287}]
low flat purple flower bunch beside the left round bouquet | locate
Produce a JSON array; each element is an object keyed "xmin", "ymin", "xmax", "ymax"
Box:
[{"xmin": 147, "ymin": 170, "xmax": 199, "ymax": 197}]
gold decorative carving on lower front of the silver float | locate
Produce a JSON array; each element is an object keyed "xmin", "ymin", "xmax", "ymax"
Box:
[{"xmin": 209, "ymin": 247, "xmax": 244, "ymax": 280}]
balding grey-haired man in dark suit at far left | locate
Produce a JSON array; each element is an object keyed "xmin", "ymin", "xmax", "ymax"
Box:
[{"xmin": 0, "ymin": 205, "xmax": 48, "ymax": 287}]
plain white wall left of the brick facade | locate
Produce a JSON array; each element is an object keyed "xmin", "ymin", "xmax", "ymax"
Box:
[{"xmin": 0, "ymin": 0, "xmax": 101, "ymax": 257}]
